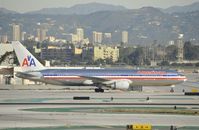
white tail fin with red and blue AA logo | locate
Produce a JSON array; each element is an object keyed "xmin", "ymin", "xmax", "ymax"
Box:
[{"xmin": 12, "ymin": 41, "xmax": 44, "ymax": 71}]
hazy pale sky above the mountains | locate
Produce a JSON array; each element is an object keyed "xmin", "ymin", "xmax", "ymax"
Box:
[{"xmin": 0, "ymin": 0, "xmax": 199, "ymax": 13}]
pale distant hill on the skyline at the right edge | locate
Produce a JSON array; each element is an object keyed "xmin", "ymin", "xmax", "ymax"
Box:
[{"xmin": 164, "ymin": 2, "xmax": 199, "ymax": 13}]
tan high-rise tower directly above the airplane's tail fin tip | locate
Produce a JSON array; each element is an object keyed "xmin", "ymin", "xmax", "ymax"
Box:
[{"xmin": 12, "ymin": 24, "xmax": 21, "ymax": 41}]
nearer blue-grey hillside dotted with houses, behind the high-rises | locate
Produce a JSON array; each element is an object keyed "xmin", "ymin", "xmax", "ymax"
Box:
[{"xmin": 0, "ymin": 3, "xmax": 199, "ymax": 44}]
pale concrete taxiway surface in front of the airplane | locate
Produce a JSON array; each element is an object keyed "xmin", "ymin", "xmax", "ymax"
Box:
[{"xmin": 0, "ymin": 85, "xmax": 199, "ymax": 129}]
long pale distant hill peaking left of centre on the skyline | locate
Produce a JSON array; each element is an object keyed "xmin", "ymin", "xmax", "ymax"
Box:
[{"xmin": 28, "ymin": 3, "xmax": 126, "ymax": 15}]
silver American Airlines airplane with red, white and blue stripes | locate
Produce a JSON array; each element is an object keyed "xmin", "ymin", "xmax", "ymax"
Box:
[{"xmin": 12, "ymin": 41, "xmax": 186, "ymax": 92}]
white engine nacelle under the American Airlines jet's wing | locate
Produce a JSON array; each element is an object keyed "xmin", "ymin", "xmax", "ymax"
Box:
[{"xmin": 111, "ymin": 80, "xmax": 130, "ymax": 90}]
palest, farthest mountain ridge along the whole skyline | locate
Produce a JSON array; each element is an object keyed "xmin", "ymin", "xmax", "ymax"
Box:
[{"xmin": 0, "ymin": 2, "xmax": 199, "ymax": 15}]
